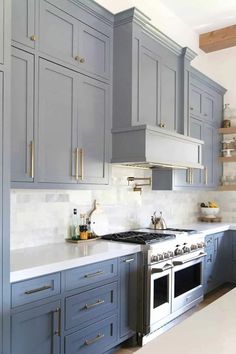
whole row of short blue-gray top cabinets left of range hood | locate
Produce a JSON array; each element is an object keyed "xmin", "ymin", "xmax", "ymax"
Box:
[{"xmin": 12, "ymin": 0, "xmax": 113, "ymax": 80}]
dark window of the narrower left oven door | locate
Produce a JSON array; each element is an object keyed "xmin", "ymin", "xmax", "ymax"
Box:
[{"xmin": 153, "ymin": 275, "xmax": 169, "ymax": 309}]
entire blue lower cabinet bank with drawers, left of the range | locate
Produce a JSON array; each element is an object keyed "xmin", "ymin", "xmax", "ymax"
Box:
[{"xmin": 11, "ymin": 254, "xmax": 138, "ymax": 354}]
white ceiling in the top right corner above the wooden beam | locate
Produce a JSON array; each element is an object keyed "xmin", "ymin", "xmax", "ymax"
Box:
[{"xmin": 161, "ymin": 0, "xmax": 236, "ymax": 33}]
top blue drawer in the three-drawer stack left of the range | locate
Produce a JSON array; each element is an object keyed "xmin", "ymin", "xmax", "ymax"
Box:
[{"xmin": 65, "ymin": 259, "xmax": 117, "ymax": 290}]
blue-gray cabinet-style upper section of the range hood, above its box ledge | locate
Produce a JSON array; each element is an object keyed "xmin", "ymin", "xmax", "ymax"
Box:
[{"xmin": 113, "ymin": 9, "xmax": 183, "ymax": 133}]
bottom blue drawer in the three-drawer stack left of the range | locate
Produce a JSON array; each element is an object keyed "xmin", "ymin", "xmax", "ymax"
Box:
[{"xmin": 65, "ymin": 315, "xmax": 118, "ymax": 354}]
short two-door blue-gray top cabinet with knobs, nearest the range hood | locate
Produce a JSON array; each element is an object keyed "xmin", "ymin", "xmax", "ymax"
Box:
[{"xmin": 39, "ymin": 0, "xmax": 111, "ymax": 79}]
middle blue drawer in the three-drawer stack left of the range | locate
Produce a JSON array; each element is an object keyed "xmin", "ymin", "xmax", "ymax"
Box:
[{"xmin": 65, "ymin": 282, "xmax": 117, "ymax": 329}]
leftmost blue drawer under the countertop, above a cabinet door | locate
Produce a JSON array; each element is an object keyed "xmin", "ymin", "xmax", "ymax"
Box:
[{"xmin": 11, "ymin": 273, "xmax": 61, "ymax": 307}]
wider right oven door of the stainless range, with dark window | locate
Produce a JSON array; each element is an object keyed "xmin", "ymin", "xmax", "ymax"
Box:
[{"xmin": 172, "ymin": 252, "xmax": 206, "ymax": 312}]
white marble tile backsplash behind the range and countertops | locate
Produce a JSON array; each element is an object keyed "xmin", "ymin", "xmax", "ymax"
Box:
[{"xmin": 11, "ymin": 167, "xmax": 236, "ymax": 249}]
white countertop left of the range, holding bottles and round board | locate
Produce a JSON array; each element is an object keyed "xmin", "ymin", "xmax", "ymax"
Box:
[{"xmin": 10, "ymin": 240, "xmax": 141, "ymax": 283}]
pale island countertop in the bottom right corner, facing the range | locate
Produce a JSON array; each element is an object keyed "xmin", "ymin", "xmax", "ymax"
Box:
[{"xmin": 135, "ymin": 288, "xmax": 236, "ymax": 354}]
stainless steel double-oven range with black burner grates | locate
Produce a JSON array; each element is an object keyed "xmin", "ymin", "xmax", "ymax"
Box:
[{"xmin": 103, "ymin": 229, "xmax": 206, "ymax": 344}]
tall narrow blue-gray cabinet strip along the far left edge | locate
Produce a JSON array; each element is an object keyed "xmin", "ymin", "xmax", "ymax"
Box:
[{"xmin": 0, "ymin": 0, "xmax": 11, "ymax": 354}]
